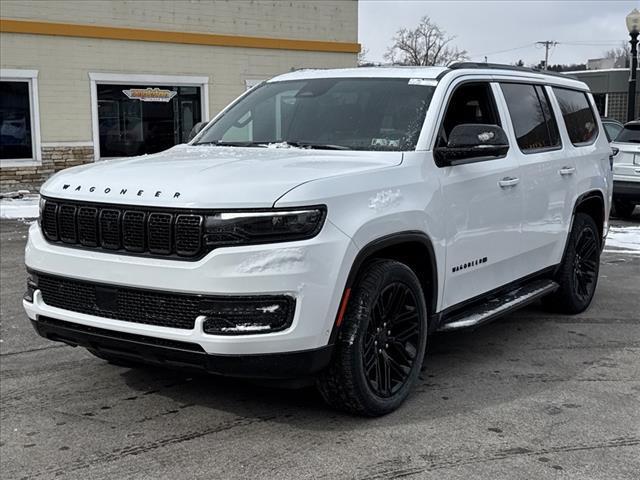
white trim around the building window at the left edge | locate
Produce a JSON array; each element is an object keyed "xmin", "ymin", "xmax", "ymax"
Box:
[{"xmin": 0, "ymin": 68, "xmax": 42, "ymax": 168}]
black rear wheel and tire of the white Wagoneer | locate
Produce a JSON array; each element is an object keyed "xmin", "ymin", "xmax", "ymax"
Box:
[{"xmin": 543, "ymin": 213, "xmax": 601, "ymax": 314}]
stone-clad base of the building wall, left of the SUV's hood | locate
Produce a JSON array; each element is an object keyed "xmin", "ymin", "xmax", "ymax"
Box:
[{"xmin": 0, "ymin": 146, "xmax": 93, "ymax": 193}]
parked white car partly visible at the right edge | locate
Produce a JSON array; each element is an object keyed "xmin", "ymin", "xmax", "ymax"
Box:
[{"xmin": 611, "ymin": 120, "xmax": 640, "ymax": 218}]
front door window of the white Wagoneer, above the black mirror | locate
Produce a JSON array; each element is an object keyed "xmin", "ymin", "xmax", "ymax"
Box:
[{"xmin": 438, "ymin": 83, "xmax": 500, "ymax": 146}]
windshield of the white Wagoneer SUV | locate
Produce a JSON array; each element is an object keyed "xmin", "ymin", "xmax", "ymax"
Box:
[{"xmin": 195, "ymin": 78, "xmax": 435, "ymax": 150}]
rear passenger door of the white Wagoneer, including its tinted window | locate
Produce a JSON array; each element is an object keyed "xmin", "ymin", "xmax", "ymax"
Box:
[{"xmin": 500, "ymin": 81, "xmax": 577, "ymax": 274}]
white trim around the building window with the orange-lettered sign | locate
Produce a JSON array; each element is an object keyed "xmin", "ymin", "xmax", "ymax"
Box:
[{"xmin": 89, "ymin": 72, "xmax": 210, "ymax": 162}]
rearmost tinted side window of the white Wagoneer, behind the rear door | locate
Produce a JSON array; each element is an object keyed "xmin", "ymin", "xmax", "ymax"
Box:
[{"xmin": 553, "ymin": 87, "xmax": 598, "ymax": 145}]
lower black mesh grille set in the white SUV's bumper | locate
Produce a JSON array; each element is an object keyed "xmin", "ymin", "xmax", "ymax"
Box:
[{"xmin": 32, "ymin": 272, "xmax": 295, "ymax": 334}]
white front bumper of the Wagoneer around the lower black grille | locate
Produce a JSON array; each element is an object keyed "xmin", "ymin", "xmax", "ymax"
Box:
[{"xmin": 23, "ymin": 221, "xmax": 357, "ymax": 358}]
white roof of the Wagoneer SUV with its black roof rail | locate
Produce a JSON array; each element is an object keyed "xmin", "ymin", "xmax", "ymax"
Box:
[{"xmin": 269, "ymin": 62, "xmax": 588, "ymax": 90}]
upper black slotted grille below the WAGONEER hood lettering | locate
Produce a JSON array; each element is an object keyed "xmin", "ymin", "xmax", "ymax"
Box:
[{"xmin": 41, "ymin": 199, "xmax": 205, "ymax": 259}]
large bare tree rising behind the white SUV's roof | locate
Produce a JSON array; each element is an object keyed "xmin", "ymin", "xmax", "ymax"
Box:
[{"xmin": 384, "ymin": 15, "xmax": 467, "ymax": 66}]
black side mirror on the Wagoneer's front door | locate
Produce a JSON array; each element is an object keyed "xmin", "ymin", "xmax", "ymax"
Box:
[{"xmin": 434, "ymin": 123, "xmax": 509, "ymax": 167}]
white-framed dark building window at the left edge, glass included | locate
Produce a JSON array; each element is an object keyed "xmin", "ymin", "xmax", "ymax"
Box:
[{"xmin": 0, "ymin": 69, "xmax": 40, "ymax": 167}]
